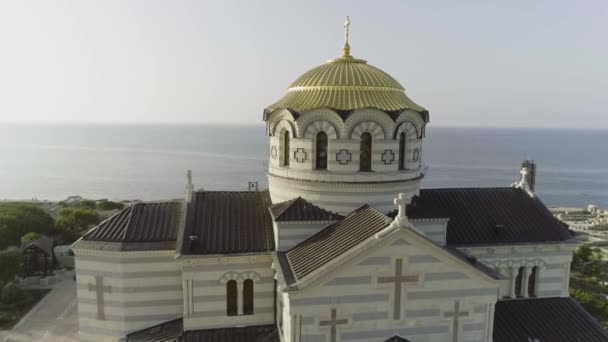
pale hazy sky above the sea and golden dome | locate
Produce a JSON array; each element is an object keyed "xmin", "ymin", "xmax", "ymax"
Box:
[{"xmin": 0, "ymin": 0, "xmax": 608, "ymax": 128}]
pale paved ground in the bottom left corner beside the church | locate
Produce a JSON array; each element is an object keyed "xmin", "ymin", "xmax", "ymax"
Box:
[{"xmin": 0, "ymin": 277, "xmax": 79, "ymax": 342}]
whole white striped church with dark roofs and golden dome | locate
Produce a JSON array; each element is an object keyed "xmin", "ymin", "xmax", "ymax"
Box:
[{"xmin": 74, "ymin": 18, "xmax": 608, "ymax": 342}]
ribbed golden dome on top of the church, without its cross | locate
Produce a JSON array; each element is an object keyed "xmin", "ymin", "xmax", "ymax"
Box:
[{"xmin": 268, "ymin": 55, "xmax": 424, "ymax": 112}]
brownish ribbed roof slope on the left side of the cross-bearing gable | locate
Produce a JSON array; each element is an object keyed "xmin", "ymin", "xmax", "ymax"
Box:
[{"xmin": 285, "ymin": 205, "xmax": 391, "ymax": 279}]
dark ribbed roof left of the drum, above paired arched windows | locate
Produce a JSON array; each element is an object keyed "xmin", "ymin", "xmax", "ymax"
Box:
[{"xmin": 181, "ymin": 191, "xmax": 274, "ymax": 255}]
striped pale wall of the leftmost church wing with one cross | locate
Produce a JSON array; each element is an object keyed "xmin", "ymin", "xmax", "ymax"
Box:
[{"xmin": 74, "ymin": 249, "xmax": 183, "ymax": 341}]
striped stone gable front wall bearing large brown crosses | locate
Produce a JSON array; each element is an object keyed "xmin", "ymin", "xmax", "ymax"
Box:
[{"xmin": 288, "ymin": 229, "xmax": 497, "ymax": 341}]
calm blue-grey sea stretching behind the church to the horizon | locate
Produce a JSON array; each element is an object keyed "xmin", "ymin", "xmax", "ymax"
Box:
[{"xmin": 0, "ymin": 123, "xmax": 608, "ymax": 208}]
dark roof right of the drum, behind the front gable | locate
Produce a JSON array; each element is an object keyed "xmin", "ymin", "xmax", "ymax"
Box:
[{"xmin": 389, "ymin": 188, "xmax": 572, "ymax": 246}]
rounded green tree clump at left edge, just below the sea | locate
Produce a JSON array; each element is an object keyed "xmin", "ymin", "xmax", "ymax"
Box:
[{"xmin": 0, "ymin": 203, "xmax": 55, "ymax": 250}]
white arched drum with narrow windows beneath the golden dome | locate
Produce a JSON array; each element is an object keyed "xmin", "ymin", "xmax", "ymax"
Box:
[{"xmin": 267, "ymin": 109, "xmax": 425, "ymax": 214}]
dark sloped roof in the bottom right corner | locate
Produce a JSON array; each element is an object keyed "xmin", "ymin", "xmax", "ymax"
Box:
[{"xmin": 493, "ymin": 298, "xmax": 608, "ymax": 342}]
